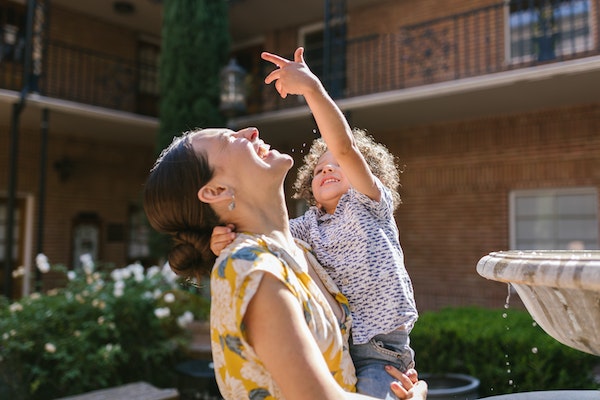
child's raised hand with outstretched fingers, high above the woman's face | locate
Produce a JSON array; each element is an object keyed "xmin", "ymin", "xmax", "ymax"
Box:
[{"xmin": 261, "ymin": 47, "xmax": 322, "ymax": 99}]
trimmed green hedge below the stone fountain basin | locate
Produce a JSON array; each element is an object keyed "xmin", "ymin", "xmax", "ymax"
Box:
[{"xmin": 411, "ymin": 307, "xmax": 600, "ymax": 397}]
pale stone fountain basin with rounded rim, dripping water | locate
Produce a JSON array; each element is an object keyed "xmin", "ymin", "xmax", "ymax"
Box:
[{"xmin": 477, "ymin": 250, "xmax": 600, "ymax": 355}]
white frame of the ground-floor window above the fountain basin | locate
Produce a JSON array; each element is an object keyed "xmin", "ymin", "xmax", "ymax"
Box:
[{"xmin": 509, "ymin": 187, "xmax": 599, "ymax": 250}]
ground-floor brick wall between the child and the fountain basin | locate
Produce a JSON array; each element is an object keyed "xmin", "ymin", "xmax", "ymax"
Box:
[{"xmin": 382, "ymin": 103, "xmax": 600, "ymax": 310}]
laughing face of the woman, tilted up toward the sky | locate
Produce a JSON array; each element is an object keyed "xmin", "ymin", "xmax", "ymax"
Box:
[{"xmin": 191, "ymin": 128, "xmax": 293, "ymax": 182}]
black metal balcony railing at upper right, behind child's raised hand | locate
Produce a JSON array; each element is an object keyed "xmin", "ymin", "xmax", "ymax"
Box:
[{"xmin": 263, "ymin": 0, "xmax": 600, "ymax": 111}]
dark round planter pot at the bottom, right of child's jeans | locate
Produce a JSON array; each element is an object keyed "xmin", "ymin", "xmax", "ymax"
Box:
[{"xmin": 419, "ymin": 374, "xmax": 479, "ymax": 400}]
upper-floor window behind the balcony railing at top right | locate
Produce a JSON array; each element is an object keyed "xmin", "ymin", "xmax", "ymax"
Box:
[{"xmin": 509, "ymin": 0, "xmax": 592, "ymax": 62}]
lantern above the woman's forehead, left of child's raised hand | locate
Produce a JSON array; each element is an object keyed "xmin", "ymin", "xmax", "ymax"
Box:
[{"xmin": 219, "ymin": 58, "xmax": 247, "ymax": 118}]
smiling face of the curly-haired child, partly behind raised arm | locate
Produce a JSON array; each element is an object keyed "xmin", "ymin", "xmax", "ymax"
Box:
[{"xmin": 312, "ymin": 151, "xmax": 350, "ymax": 214}]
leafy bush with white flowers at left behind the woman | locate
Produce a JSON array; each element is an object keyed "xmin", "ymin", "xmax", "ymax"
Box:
[{"xmin": 0, "ymin": 256, "xmax": 208, "ymax": 399}]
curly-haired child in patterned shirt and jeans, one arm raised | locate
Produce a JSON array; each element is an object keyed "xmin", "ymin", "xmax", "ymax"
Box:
[{"xmin": 211, "ymin": 48, "xmax": 418, "ymax": 398}]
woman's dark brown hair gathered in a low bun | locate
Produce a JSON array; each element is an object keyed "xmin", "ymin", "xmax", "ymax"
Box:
[{"xmin": 144, "ymin": 131, "xmax": 219, "ymax": 278}]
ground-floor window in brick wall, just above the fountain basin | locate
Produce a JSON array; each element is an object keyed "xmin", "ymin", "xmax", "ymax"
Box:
[{"xmin": 510, "ymin": 188, "xmax": 598, "ymax": 250}]
